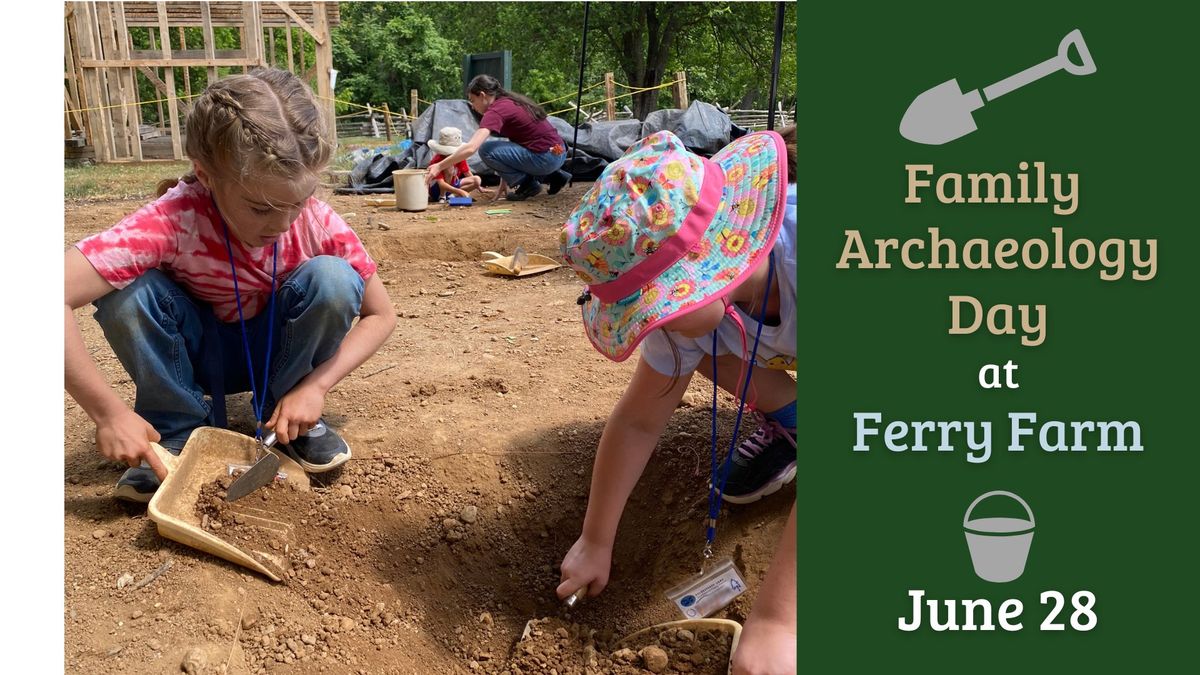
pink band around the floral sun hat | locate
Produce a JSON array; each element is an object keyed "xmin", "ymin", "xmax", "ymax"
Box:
[{"xmin": 588, "ymin": 157, "xmax": 725, "ymax": 303}]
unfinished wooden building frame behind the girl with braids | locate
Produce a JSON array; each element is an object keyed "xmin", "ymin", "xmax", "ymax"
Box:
[{"xmin": 64, "ymin": 1, "xmax": 340, "ymax": 162}]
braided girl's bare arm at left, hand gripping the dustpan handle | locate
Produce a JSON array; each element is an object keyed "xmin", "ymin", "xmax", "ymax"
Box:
[{"xmin": 62, "ymin": 247, "xmax": 167, "ymax": 478}]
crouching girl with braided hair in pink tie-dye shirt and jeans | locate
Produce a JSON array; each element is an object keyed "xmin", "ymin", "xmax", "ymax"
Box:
[{"xmin": 64, "ymin": 68, "xmax": 396, "ymax": 501}]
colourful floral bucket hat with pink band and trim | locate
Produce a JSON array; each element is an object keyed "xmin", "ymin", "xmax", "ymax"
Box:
[{"xmin": 559, "ymin": 131, "xmax": 787, "ymax": 362}]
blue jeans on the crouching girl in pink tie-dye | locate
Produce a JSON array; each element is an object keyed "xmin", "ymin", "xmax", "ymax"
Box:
[{"xmin": 95, "ymin": 256, "xmax": 364, "ymax": 449}]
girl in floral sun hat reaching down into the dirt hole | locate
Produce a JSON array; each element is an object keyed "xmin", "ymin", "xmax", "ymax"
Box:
[{"xmin": 558, "ymin": 127, "xmax": 796, "ymax": 629}]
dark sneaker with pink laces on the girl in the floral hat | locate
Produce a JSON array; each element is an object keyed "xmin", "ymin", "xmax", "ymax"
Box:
[{"xmin": 722, "ymin": 413, "xmax": 796, "ymax": 504}]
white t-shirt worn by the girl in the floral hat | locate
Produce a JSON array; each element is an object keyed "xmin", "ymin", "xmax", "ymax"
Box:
[{"xmin": 641, "ymin": 183, "xmax": 797, "ymax": 375}]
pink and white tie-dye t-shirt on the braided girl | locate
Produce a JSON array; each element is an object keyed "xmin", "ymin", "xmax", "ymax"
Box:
[{"xmin": 76, "ymin": 181, "xmax": 377, "ymax": 322}]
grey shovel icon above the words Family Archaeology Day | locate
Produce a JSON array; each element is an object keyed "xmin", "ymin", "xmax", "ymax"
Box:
[{"xmin": 900, "ymin": 29, "xmax": 1096, "ymax": 145}]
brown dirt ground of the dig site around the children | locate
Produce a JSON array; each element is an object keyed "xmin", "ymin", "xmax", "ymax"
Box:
[{"xmin": 64, "ymin": 184, "xmax": 794, "ymax": 674}]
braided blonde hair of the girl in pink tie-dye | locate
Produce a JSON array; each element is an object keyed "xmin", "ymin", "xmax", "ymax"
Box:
[{"xmin": 158, "ymin": 68, "xmax": 332, "ymax": 196}]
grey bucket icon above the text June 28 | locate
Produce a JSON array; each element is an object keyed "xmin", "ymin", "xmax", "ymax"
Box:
[{"xmin": 962, "ymin": 490, "xmax": 1033, "ymax": 584}]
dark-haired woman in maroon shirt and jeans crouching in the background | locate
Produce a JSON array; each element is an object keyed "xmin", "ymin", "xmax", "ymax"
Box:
[{"xmin": 427, "ymin": 74, "xmax": 571, "ymax": 202}]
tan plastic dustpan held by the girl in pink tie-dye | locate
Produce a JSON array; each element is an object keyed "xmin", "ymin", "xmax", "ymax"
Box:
[{"xmin": 149, "ymin": 426, "xmax": 310, "ymax": 581}]
